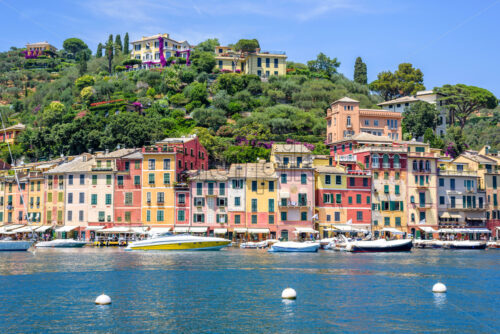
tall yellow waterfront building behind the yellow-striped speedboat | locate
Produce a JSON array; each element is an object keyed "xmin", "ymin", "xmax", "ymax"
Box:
[{"xmin": 141, "ymin": 146, "xmax": 176, "ymax": 227}]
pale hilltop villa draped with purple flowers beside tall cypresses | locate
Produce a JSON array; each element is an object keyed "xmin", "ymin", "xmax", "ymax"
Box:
[{"xmin": 130, "ymin": 34, "xmax": 192, "ymax": 63}]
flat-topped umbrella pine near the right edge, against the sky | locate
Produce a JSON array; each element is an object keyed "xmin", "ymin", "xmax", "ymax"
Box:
[{"xmin": 435, "ymin": 84, "xmax": 498, "ymax": 129}]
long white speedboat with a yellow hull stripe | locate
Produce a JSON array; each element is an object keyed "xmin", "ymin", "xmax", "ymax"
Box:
[{"xmin": 125, "ymin": 234, "xmax": 231, "ymax": 251}]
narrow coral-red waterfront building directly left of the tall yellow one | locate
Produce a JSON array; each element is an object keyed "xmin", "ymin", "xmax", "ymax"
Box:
[{"xmin": 113, "ymin": 149, "xmax": 143, "ymax": 227}]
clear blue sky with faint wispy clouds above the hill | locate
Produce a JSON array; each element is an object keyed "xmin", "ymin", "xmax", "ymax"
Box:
[{"xmin": 0, "ymin": 0, "xmax": 500, "ymax": 97}]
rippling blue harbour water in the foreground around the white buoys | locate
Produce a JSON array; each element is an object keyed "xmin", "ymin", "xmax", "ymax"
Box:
[{"xmin": 0, "ymin": 248, "xmax": 500, "ymax": 333}]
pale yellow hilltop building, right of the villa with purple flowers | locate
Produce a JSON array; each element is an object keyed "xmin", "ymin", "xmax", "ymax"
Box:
[{"xmin": 215, "ymin": 46, "xmax": 287, "ymax": 78}]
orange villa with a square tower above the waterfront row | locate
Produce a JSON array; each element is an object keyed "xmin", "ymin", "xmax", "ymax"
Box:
[{"xmin": 326, "ymin": 97, "xmax": 402, "ymax": 144}]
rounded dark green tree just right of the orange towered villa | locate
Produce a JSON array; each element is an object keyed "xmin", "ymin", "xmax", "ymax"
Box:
[{"xmin": 402, "ymin": 101, "xmax": 439, "ymax": 138}]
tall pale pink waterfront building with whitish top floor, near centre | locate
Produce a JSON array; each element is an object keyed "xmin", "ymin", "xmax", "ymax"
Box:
[{"xmin": 271, "ymin": 143, "xmax": 316, "ymax": 240}]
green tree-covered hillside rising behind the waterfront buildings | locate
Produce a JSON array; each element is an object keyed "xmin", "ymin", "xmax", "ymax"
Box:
[{"xmin": 0, "ymin": 41, "xmax": 500, "ymax": 165}]
